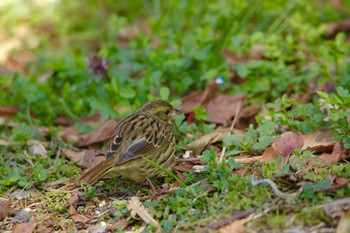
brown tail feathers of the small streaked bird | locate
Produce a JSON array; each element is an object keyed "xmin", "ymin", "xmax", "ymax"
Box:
[{"xmin": 78, "ymin": 160, "xmax": 113, "ymax": 185}]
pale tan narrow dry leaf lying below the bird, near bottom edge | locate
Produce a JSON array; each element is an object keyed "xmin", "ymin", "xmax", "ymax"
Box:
[{"xmin": 128, "ymin": 196, "xmax": 160, "ymax": 229}]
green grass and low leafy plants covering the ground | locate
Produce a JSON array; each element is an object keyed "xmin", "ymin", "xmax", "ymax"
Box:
[{"xmin": 0, "ymin": 0, "xmax": 350, "ymax": 232}]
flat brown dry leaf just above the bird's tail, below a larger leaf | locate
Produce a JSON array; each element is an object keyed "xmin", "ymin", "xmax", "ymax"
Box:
[{"xmin": 63, "ymin": 149, "xmax": 106, "ymax": 168}]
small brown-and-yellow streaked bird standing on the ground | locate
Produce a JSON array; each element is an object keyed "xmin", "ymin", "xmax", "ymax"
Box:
[{"xmin": 79, "ymin": 100, "xmax": 180, "ymax": 189}]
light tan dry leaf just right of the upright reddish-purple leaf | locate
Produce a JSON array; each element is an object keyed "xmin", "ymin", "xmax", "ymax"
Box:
[{"xmin": 301, "ymin": 129, "xmax": 335, "ymax": 152}]
